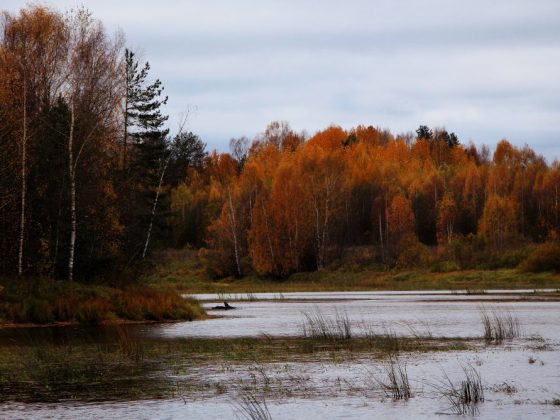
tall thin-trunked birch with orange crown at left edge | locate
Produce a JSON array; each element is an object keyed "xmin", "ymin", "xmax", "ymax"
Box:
[{"xmin": 0, "ymin": 7, "xmax": 65, "ymax": 276}]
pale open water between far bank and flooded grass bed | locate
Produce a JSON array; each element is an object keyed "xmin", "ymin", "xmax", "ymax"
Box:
[{"xmin": 152, "ymin": 291, "xmax": 560, "ymax": 340}]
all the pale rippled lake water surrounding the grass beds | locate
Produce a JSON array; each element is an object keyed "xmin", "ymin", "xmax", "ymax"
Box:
[{"xmin": 0, "ymin": 291, "xmax": 560, "ymax": 419}]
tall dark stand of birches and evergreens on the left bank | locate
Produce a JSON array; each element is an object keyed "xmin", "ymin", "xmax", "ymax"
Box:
[{"xmin": 0, "ymin": 6, "xmax": 205, "ymax": 280}]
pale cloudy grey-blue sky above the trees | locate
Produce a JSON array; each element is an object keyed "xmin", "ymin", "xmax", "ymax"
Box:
[{"xmin": 4, "ymin": 0, "xmax": 560, "ymax": 163}]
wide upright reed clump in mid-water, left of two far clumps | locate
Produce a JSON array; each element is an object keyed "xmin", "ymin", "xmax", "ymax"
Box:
[{"xmin": 302, "ymin": 309, "xmax": 352, "ymax": 342}]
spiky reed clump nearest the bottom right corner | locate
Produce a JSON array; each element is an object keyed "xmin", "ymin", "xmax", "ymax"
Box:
[{"xmin": 430, "ymin": 365, "xmax": 484, "ymax": 415}]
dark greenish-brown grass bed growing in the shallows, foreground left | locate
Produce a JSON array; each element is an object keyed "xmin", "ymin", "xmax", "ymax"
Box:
[{"xmin": 0, "ymin": 325, "xmax": 469, "ymax": 402}]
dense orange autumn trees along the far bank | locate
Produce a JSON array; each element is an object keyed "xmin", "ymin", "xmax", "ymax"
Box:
[{"xmin": 190, "ymin": 123, "xmax": 560, "ymax": 277}]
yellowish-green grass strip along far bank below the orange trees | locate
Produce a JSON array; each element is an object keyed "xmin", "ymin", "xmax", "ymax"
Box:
[{"xmin": 142, "ymin": 250, "xmax": 560, "ymax": 299}]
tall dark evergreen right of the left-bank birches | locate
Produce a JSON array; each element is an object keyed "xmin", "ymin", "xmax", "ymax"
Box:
[{"xmin": 121, "ymin": 49, "xmax": 171, "ymax": 260}]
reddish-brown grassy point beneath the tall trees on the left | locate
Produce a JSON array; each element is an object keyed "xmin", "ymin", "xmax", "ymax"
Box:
[{"xmin": 0, "ymin": 278, "xmax": 204, "ymax": 325}]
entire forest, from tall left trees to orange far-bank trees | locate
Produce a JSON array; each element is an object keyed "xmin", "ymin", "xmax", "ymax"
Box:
[{"xmin": 0, "ymin": 6, "xmax": 560, "ymax": 284}]
